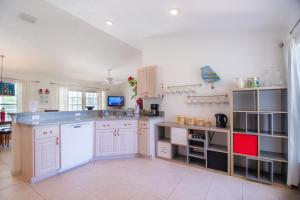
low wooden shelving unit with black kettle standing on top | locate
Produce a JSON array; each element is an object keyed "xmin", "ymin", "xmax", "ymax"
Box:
[{"xmin": 156, "ymin": 122, "xmax": 231, "ymax": 174}]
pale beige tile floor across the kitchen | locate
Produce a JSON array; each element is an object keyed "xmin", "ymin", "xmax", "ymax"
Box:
[{"xmin": 0, "ymin": 152, "xmax": 300, "ymax": 200}]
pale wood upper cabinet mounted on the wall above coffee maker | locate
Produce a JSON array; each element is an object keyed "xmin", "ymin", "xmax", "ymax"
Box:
[{"xmin": 137, "ymin": 66, "xmax": 158, "ymax": 98}]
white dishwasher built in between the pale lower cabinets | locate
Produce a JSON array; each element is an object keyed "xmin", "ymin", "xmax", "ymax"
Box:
[{"xmin": 60, "ymin": 122, "xmax": 93, "ymax": 172}]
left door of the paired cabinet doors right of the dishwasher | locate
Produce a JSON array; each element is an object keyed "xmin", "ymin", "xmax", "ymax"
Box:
[{"xmin": 95, "ymin": 129, "xmax": 116, "ymax": 156}]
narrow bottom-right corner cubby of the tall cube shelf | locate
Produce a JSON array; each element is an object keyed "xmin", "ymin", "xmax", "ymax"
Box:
[{"xmin": 273, "ymin": 161, "xmax": 288, "ymax": 185}]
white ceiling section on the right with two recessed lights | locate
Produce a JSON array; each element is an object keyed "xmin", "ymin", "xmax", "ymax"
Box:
[{"xmin": 46, "ymin": 0, "xmax": 300, "ymax": 48}]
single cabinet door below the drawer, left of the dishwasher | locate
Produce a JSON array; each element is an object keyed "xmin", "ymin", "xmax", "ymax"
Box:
[{"xmin": 35, "ymin": 137, "xmax": 60, "ymax": 176}]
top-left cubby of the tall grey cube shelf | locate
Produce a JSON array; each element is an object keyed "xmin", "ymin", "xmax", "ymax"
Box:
[{"xmin": 233, "ymin": 90, "xmax": 257, "ymax": 111}]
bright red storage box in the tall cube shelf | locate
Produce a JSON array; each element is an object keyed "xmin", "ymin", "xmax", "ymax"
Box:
[{"xmin": 233, "ymin": 133, "xmax": 258, "ymax": 156}]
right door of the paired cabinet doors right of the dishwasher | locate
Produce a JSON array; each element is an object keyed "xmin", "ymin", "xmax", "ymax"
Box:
[{"xmin": 117, "ymin": 129, "xmax": 137, "ymax": 154}]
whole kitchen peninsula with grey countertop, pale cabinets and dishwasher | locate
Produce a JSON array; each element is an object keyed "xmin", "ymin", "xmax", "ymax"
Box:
[{"xmin": 13, "ymin": 110, "xmax": 162, "ymax": 183}]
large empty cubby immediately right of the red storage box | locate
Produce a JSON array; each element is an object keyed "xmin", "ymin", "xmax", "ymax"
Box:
[{"xmin": 259, "ymin": 136, "xmax": 288, "ymax": 162}]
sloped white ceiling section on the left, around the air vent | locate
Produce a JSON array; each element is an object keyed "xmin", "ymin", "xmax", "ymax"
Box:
[{"xmin": 0, "ymin": 0, "xmax": 141, "ymax": 82}]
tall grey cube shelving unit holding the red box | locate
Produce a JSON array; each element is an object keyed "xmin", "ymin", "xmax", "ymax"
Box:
[{"xmin": 231, "ymin": 87, "xmax": 289, "ymax": 185}]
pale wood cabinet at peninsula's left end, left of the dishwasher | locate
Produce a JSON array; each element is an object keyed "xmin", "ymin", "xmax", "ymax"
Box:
[{"xmin": 18, "ymin": 125, "xmax": 60, "ymax": 183}]
